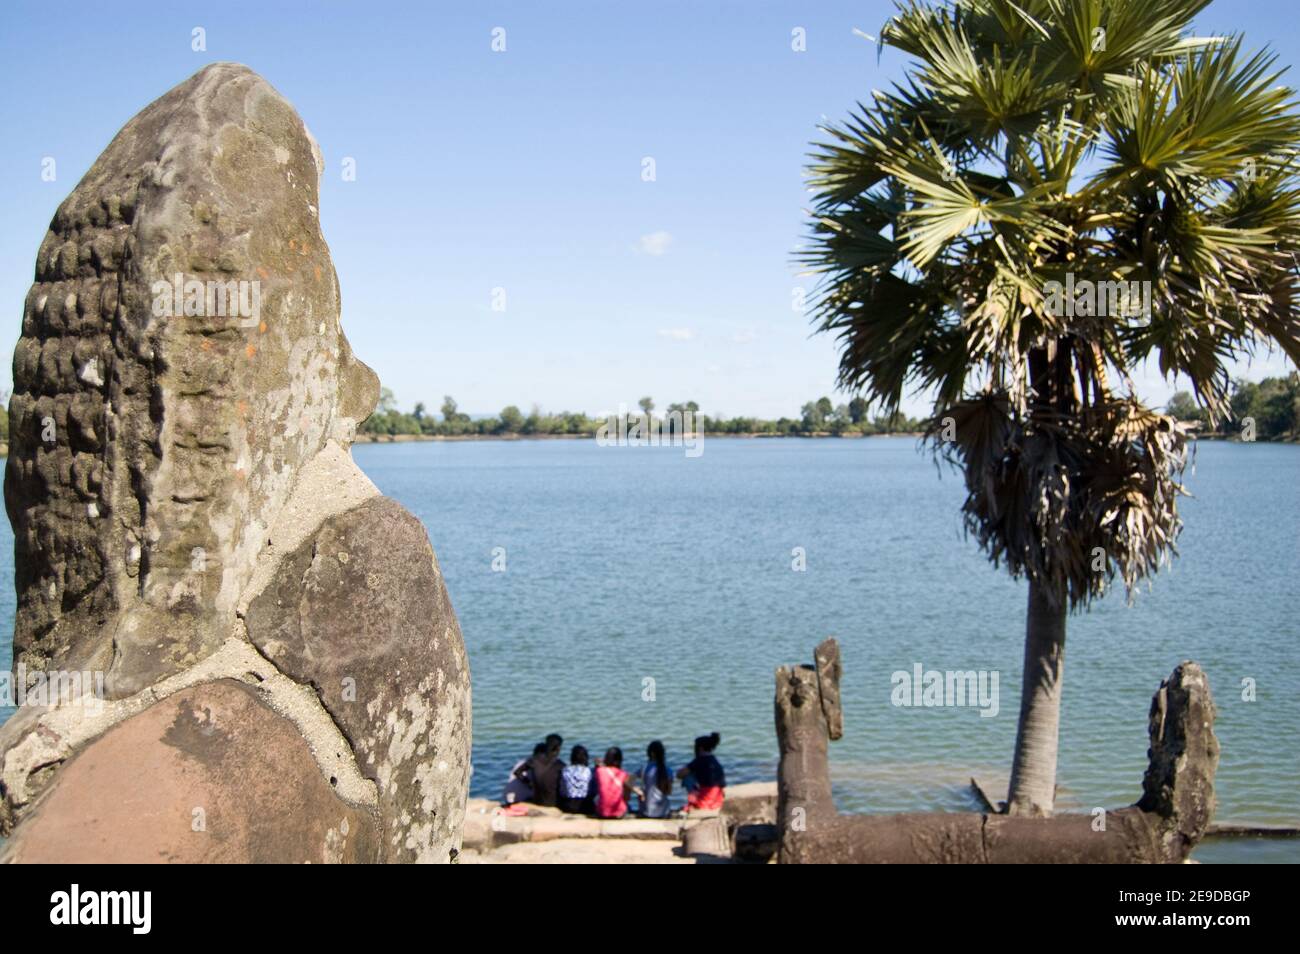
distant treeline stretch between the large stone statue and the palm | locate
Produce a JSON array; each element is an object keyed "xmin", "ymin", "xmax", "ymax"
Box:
[{"xmin": 361, "ymin": 387, "xmax": 922, "ymax": 437}]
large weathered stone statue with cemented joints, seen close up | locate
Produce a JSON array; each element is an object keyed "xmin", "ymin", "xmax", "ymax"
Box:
[{"xmin": 0, "ymin": 64, "xmax": 469, "ymax": 862}]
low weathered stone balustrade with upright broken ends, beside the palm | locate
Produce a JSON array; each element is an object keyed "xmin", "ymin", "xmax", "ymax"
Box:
[{"xmin": 776, "ymin": 639, "xmax": 1218, "ymax": 864}]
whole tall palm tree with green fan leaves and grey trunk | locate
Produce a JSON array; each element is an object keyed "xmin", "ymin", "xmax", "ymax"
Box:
[{"xmin": 802, "ymin": 0, "xmax": 1300, "ymax": 815}]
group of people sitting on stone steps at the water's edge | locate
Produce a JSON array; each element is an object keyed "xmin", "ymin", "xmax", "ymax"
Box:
[{"xmin": 502, "ymin": 732, "xmax": 727, "ymax": 819}]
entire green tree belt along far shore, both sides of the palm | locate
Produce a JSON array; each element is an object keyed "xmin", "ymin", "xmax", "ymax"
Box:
[{"xmin": 356, "ymin": 372, "xmax": 1300, "ymax": 442}]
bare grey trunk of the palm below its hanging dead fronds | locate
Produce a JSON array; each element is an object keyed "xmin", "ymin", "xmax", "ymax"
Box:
[{"xmin": 1006, "ymin": 580, "xmax": 1066, "ymax": 816}]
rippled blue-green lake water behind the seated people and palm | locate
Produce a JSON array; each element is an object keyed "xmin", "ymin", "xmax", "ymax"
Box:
[{"xmin": 0, "ymin": 438, "xmax": 1300, "ymax": 860}]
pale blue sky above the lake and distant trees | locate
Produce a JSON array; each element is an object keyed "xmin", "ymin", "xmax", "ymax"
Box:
[{"xmin": 0, "ymin": 0, "xmax": 1300, "ymax": 417}]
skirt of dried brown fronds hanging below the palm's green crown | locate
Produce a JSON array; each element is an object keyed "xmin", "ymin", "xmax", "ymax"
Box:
[{"xmin": 928, "ymin": 393, "xmax": 1187, "ymax": 607}]
